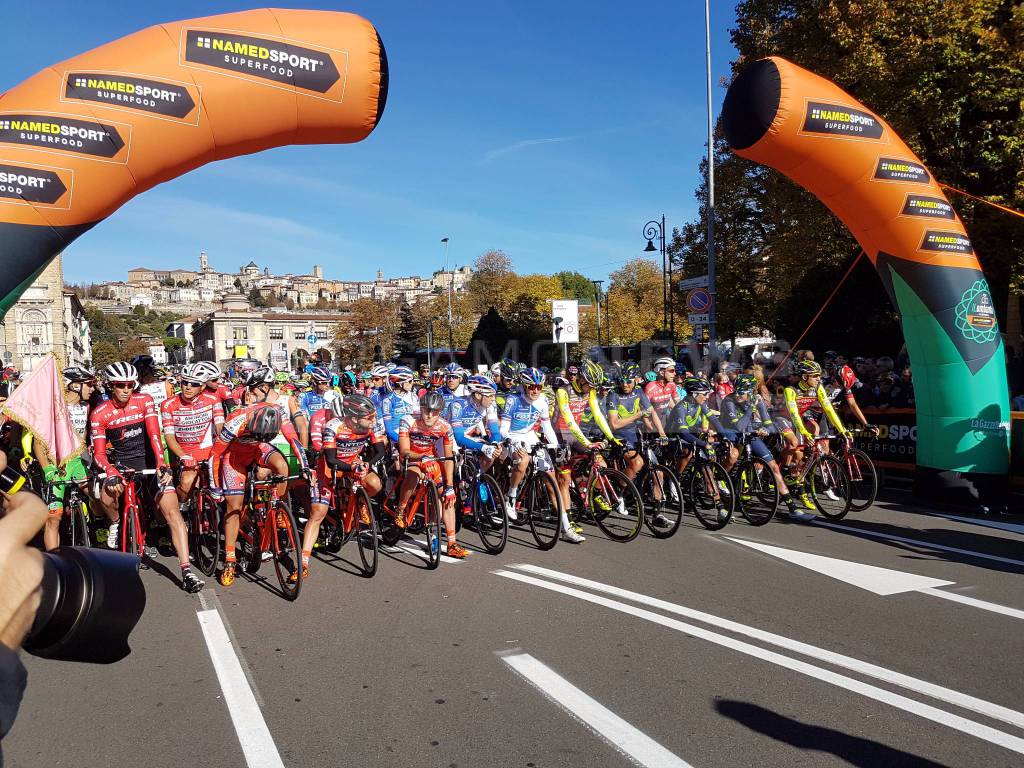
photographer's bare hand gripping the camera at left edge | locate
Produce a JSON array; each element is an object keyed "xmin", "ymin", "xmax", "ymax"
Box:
[{"xmin": 0, "ymin": 452, "xmax": 48, "ymax": 650}]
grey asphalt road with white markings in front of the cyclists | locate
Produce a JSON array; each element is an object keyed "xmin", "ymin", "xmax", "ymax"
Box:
[{"xmin": 3, "ymin": 499, "xmax": 1024, "ymax": 768}]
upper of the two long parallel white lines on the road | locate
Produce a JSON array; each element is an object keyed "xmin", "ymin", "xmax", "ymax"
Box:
[{"xmin": 495, "ymin": 563, "xmax": 1024, "ymax": 728}]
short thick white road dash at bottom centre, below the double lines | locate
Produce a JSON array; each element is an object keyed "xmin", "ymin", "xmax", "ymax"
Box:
[{"xmin": 502, "ymin": 653, "xmax": 692, "ymax": 768}]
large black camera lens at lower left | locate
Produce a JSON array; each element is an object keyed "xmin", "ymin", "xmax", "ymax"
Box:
[{"xmin": 23, "ymin": 547, "xmax": 145, "ymax": 664}]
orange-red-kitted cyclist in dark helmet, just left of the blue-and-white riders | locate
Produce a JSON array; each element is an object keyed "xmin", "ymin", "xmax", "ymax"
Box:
[{"xmin": 395, "ymin": 391, "xmax": 469, "ymax": 559}]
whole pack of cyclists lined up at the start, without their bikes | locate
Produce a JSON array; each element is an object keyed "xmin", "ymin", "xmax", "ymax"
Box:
[{"xmin": 0, "ymin": 353, "xmax": 870, "ymax": 592}]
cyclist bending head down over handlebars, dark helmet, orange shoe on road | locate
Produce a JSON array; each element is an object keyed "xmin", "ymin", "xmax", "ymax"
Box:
[{"xmin": 210, "ymin": 402, "xmax": 308, "ymax": 587}]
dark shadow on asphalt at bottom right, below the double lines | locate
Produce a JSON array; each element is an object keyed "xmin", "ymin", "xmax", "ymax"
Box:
[{"xmin": 715, "ymin": 698, "xmax": 949, "ymax": 768}]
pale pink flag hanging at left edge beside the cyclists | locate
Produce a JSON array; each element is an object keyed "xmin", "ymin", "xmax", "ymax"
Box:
[{"xmin": 0, "ymin": 354, "xmax": 83, "ymax": 464}]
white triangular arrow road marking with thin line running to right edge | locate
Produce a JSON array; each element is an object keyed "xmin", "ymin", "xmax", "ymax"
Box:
[{"xmin": 723, "ymin": 536, "xmax": 1024, "ymax": 618}]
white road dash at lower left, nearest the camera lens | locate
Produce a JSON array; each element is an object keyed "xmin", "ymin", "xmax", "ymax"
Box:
[{"xmin": 197, "ymin": 606, "xmax": 285, "ymax": 768}]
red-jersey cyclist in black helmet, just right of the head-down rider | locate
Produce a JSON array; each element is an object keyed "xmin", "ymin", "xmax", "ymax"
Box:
[{"xmin": 302, "ymin": 394, "xmax": 387, "ymax": 579}]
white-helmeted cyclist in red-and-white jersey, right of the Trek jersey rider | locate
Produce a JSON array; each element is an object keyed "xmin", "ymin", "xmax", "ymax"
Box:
[{"xmin": 160, "ymin": 364, "xmax": 224, "ymax": 502}]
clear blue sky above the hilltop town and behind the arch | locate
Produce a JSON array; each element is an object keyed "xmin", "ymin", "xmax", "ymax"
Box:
[{"xmin": 0, "ymin": 0, "xmax": 734, "ymax": 283}]
